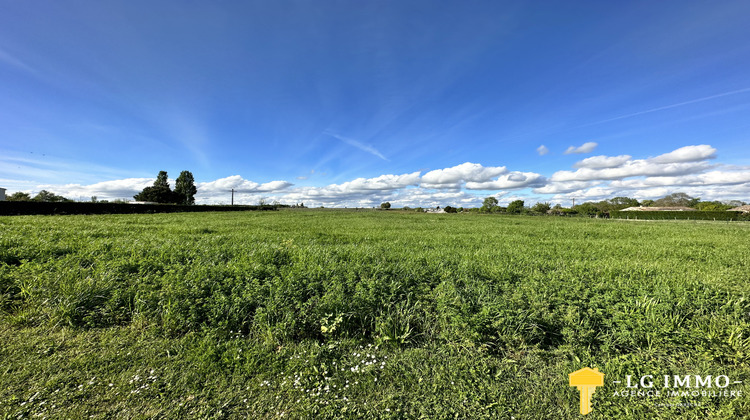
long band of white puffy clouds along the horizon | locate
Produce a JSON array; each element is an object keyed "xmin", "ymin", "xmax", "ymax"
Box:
[{"xmin": 8, "ymin": 145, "xmax": 750, "ymax": 207}]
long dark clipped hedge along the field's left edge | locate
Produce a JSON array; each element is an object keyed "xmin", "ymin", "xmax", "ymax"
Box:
[{"xmin": 0, "ymin": 201, "xmax": 276, "ymax": 216}]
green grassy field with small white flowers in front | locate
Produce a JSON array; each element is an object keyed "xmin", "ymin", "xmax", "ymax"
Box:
[{"xmin": 0, "ymin": 211, "xmax": 750, "ymax": 419}]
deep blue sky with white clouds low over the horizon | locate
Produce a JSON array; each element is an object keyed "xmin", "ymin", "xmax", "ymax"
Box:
[{"xmin": 0, "ymin": 0, "xmax": 750, "ymax": 207}]
